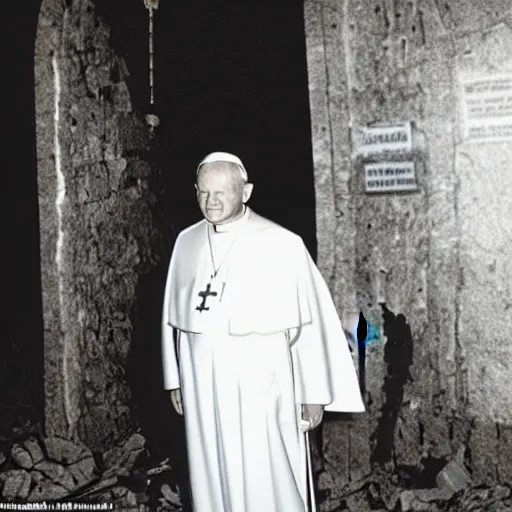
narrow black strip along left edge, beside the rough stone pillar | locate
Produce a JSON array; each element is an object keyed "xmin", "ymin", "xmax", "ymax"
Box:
[{"xmin": 10, "ymin": 0, "xmax": 44, "ymax": 440}]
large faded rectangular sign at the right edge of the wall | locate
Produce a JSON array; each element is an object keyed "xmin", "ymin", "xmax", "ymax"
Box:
[{"xmin": 461, "ymin": 73, "xmax": 512, "ymax": 142}]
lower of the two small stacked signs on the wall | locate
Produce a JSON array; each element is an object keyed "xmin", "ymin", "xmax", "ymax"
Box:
[{"xmin": 364, "ymin": 162, "xmax": 418, "ymax": 193}]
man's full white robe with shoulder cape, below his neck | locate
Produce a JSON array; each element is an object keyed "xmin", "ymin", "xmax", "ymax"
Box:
[{"xmin": 162, "ymin": 208, "xmax": 364, "ymax": 512}]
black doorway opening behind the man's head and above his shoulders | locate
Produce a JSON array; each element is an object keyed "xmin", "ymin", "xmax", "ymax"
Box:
[{"xmin": 98, "ymin": 0, "xmax": 316, "ymax": 258}]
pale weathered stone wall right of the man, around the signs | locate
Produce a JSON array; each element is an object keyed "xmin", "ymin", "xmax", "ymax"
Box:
[{"xmin": 305, "ymin": 0, "xmax": 512, "ymax": 487}]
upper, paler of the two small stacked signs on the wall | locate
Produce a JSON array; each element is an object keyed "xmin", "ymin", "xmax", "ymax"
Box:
[{"xmin": 352, "ymin": 121, "xmax": 412, "ymax": 155}]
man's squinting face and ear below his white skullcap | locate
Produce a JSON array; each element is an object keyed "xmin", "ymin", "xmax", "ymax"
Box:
[{"xmin": 196, "ymin": 162, "xmax": 250, "ymax": 224}]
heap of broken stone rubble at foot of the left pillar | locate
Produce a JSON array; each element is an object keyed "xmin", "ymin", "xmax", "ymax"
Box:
[{"xmin": 0, "ymin": 432, "xmax": 182, "ymax": 512}]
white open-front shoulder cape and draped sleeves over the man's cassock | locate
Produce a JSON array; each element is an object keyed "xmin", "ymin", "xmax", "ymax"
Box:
[{"xmin": 163, "ymin": 211, "xmax": 364, "ymax": 412}]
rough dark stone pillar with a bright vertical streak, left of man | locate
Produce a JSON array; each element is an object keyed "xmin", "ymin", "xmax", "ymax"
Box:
[{"xmin": 35, "ymin": 0, "xmax": 156, "ymax": 448}]
